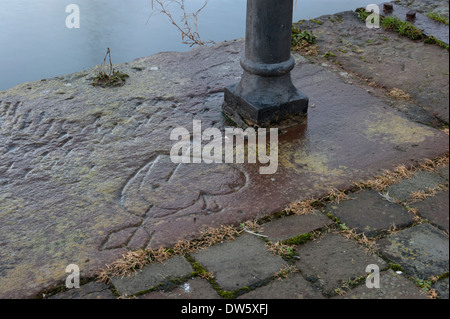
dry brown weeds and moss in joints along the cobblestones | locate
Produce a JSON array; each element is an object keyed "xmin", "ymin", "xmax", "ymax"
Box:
[{"xmin": 97, "ymin": 154, "xmax": 449, "ymax": 298}]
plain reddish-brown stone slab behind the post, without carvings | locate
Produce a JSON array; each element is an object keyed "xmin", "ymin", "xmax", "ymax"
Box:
[{"xmin": 298, "ymin": 8, "xmax": 449, "ymax": 126}]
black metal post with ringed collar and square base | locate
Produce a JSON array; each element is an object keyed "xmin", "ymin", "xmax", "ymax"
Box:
[{"xmin": 223, "ymin": 0, "xmax": 308, "ymax": 127}]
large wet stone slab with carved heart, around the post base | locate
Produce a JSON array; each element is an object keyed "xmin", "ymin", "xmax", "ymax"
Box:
[{"xmin": 0, "ymin": 34, "xmax": 448, "ymax": 298}]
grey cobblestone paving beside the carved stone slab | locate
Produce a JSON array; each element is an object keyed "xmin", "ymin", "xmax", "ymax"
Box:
[{"xmin": 47, "ymin": 166, "xmax": 449, "ymax": 299}]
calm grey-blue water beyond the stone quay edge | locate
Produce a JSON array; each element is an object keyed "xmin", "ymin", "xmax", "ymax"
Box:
[{"xmin": 0, "ymin": 0, "xmax": 373, "ymax": 90}]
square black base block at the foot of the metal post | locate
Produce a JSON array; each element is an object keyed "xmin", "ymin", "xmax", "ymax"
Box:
[{"xmin": 222, "ymin": 84, "xmax": 309, "ymax": 128}]
